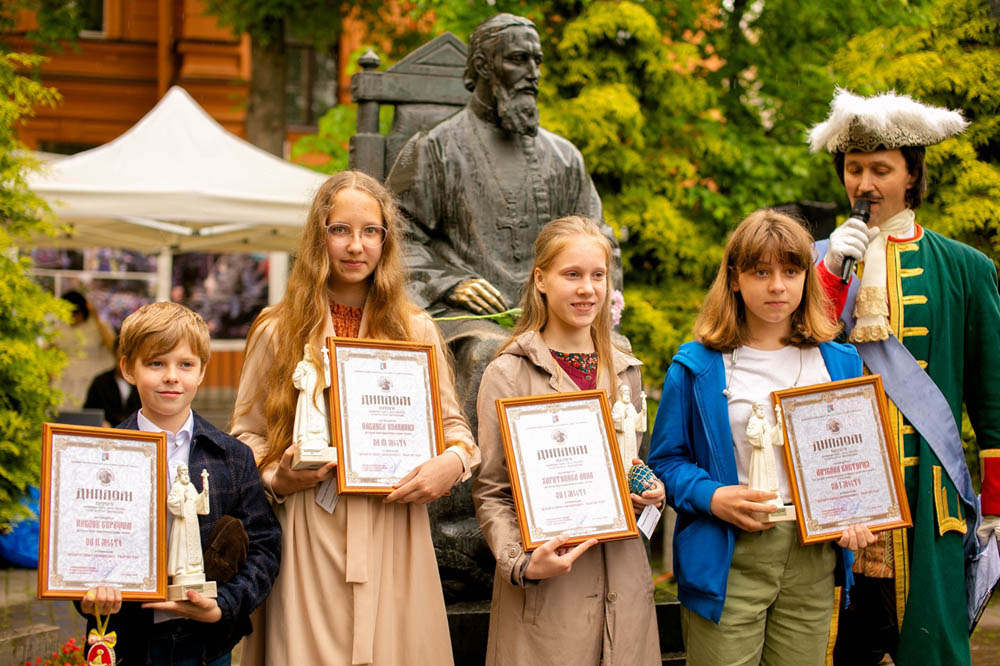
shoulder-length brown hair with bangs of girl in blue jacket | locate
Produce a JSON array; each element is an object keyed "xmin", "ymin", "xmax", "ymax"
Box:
[{"xmin": 694, "ymin": 209, "xmax": 840, "ymax": 352}]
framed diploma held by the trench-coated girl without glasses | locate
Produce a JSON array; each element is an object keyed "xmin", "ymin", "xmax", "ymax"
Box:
[{"xmin": 496, "ymin": 391, "xmax": 639, "ymax": 551}]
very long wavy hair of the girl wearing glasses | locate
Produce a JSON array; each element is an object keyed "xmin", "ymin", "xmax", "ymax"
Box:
[{"xmin": 233, "ymin": 171, "xmax": 418, "ymax": 469}]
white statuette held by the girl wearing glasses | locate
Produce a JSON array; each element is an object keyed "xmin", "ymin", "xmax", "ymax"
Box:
[{"xmin": 292, "ymin": 343, "xmax": 337, "ymax": 471}]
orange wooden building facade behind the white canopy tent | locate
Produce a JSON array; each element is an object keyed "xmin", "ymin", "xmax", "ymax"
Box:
[{"xmin": 5, "ymin": 0, "xmax": 363, "ymax": 153}]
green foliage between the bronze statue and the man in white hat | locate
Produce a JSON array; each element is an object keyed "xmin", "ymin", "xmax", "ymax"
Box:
[{"xmin": 542, "ymin": 0, "xmax": 923, "ymax": 384}]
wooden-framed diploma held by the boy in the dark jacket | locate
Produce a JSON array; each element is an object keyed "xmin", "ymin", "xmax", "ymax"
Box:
[{"xmin": 38, "ymin": 423, "xmax": 167, "ymax": 601}]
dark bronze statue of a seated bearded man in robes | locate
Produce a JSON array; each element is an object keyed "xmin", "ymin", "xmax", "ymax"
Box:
[{"xmin": 386, "ymin": 14, "xmax": 620, "ymax": 414}]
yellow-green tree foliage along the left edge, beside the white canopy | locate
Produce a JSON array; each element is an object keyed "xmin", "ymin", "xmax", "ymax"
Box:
[{"xmin": 0, "ymin": 53, "xmax": 69, "ymax": 529}]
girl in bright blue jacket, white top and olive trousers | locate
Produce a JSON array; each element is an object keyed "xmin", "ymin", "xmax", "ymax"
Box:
[{"xmin": 649, "ymin": 210, "xmax": 874, "ymax": 666}]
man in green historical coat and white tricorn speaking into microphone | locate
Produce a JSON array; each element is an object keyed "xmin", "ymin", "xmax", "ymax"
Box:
[{"xmin": 810, "ymin": 90, "xmax": 1000, "ymax": 666}]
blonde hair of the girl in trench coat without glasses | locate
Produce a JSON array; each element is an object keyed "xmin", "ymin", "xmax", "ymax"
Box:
[{"xmin": 508, "ymin": 215, "xmax": 616, "ymax": 388}]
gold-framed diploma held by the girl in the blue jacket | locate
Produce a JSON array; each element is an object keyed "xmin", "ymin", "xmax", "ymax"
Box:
[{"xmin": 771, "ymin": 375, "xmax": 913, "ymax": 544}]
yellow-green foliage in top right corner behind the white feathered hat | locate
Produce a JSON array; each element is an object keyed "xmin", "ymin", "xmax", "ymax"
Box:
[{"xmin": 834, "ymin": 0, "xmax": 1000, "ymax": 263}]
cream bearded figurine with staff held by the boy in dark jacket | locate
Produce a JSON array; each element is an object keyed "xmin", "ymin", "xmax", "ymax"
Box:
[{"xmin": 167, "ymin": 464, "xmax": 208, "ymax": 576}]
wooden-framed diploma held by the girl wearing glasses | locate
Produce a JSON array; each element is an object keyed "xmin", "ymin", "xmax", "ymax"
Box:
[{"xmin": 326, "ymin": 338, "xmax": 444, "ymax": 495}]
